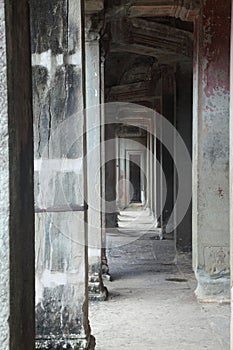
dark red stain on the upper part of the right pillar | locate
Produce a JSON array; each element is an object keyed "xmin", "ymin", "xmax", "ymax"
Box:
[{"xmin": 203, "ymin": 1, "xmax": 231, "ymax": 98}]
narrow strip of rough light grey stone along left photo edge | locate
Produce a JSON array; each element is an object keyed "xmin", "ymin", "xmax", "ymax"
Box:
[{"xmin": 0, "ymin": 1, "xmax": 10, "ymax": 350}]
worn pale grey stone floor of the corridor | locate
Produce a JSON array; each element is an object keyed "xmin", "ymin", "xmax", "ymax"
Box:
[{"xmin": 90, "ymin": 232, "xmax": 230, "ymax": 350}]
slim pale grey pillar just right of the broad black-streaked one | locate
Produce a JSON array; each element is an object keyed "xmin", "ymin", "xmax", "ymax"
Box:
[{"xmin": 85, "ymin": 32, "xmax": 107, "ymax": 300}]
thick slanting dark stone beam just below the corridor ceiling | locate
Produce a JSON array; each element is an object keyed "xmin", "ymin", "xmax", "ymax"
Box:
[{"xmin": 110, "ymin": 18, "xmax": 193, "ymax": 63}]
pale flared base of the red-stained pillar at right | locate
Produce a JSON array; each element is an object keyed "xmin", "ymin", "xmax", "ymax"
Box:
[{"xmin": 195, "ymin": 271, "xmax": 230, "ymax": 303}]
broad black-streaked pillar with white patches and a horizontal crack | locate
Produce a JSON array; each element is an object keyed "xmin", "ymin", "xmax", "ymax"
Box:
[{"xmin": 31, "ymin": 0, "xmax": 94, "ymax": 350}]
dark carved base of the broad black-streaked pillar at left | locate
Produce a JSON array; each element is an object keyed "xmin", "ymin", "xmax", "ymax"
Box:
[{"xmin": 35, "ymin": 335, "xmax": 96, "ymax": 350}]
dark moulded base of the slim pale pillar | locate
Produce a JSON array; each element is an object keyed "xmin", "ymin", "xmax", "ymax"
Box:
[{"xmin": 88, "ymin": 273, "xmax": 108, "ymax": 301}]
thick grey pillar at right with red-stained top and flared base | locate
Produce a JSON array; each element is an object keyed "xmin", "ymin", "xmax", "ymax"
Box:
[{"xmin": 193, "ymin": 0, "xmax": 231, "ymax": 301}]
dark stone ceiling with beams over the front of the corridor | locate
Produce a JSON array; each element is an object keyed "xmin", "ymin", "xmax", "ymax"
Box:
[{"xmin": 85, "ymin": 0, "xmax": 196, "ymax": 94}]
